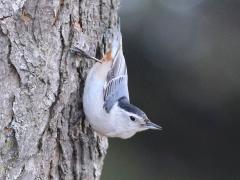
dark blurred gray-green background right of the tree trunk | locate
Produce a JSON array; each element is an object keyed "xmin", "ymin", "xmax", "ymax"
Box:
[{"xmin": 101, "ymin": 0, "xmax": 240, "ymax": 180}]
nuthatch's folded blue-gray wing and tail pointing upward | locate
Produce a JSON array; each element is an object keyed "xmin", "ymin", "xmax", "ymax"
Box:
[{"xmin": 103, "ymin": 32, "xmax": 129, "ymax": 112}]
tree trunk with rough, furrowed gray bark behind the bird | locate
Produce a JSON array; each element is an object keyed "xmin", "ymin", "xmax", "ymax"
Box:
[{"xmin": 0, "ymin": 0, "xmax": 119, "ymax": 180}]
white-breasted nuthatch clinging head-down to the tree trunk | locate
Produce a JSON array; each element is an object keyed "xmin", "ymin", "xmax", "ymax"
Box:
[{"xmin": 72, "ymin": 28, "xmax": 162, "ymax": 139}]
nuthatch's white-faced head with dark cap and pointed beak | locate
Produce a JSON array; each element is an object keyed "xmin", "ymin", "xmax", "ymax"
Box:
[{"xmin": 110, "ymin": 98, "xmax": 162, "ymax": 139}]
